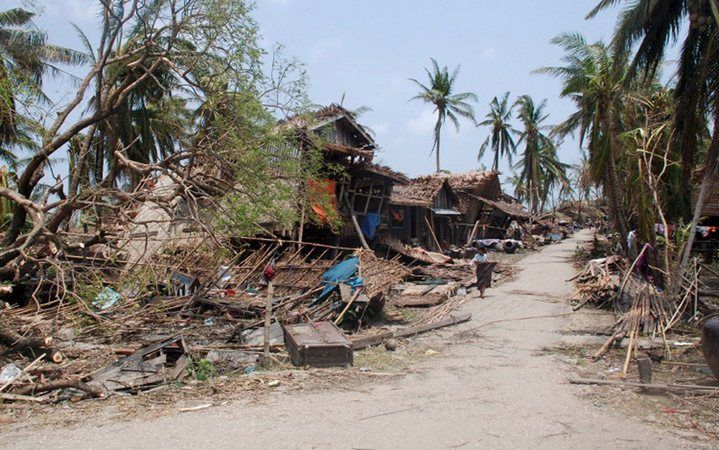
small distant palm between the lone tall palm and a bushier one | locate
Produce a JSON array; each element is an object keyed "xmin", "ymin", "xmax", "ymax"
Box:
[{"xmin": 477, "ymin": 92, "xmax": 517, "ymax": 170}]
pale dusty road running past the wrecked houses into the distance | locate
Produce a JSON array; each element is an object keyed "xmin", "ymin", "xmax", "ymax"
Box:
[{"xmin": 0, "ymin": 233, "xmax": 697, "ymax": 449}]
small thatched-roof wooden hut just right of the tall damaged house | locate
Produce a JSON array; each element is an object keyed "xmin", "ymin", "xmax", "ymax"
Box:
[{"xmin": 387, "ymin": 175, "xmax": 462, "ymax": 251}]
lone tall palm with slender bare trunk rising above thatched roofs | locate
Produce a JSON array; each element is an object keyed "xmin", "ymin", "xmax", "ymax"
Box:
[{"xmin": 410, "ymin": 58, "xmax": 477, "ymax": 173}]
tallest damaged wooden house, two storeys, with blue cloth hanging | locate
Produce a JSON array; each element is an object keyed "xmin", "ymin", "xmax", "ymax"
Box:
[{"xmin": 287, "ymin": 104, "xmax": 409, "ymax": 246}]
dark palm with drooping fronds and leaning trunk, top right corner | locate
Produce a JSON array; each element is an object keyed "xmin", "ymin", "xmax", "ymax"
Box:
[{"xmin": 588, "ymin": 0, "xmax": 719, "ymax": 279}]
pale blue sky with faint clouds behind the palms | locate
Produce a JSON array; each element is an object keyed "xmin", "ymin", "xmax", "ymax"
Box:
[{"xmin": 7, "ymin": 0, "xmax": 640, "ymax": 188}]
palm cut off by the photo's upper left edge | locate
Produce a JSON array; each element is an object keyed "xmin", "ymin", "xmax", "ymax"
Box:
[{"xmin": 0, "ymin": 8, "xmax": 87, "ymax": 145}]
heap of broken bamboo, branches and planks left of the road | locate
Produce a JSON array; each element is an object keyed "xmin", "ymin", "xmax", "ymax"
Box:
[{"xmin": 0, "ymin": 236, "xmax": 410, "ymax": 401}]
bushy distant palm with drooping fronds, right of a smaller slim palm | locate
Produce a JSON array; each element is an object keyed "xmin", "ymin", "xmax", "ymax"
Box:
[{"xmin": 515, "ymin": 95, "xmax": 568, "ymax": 213}]
